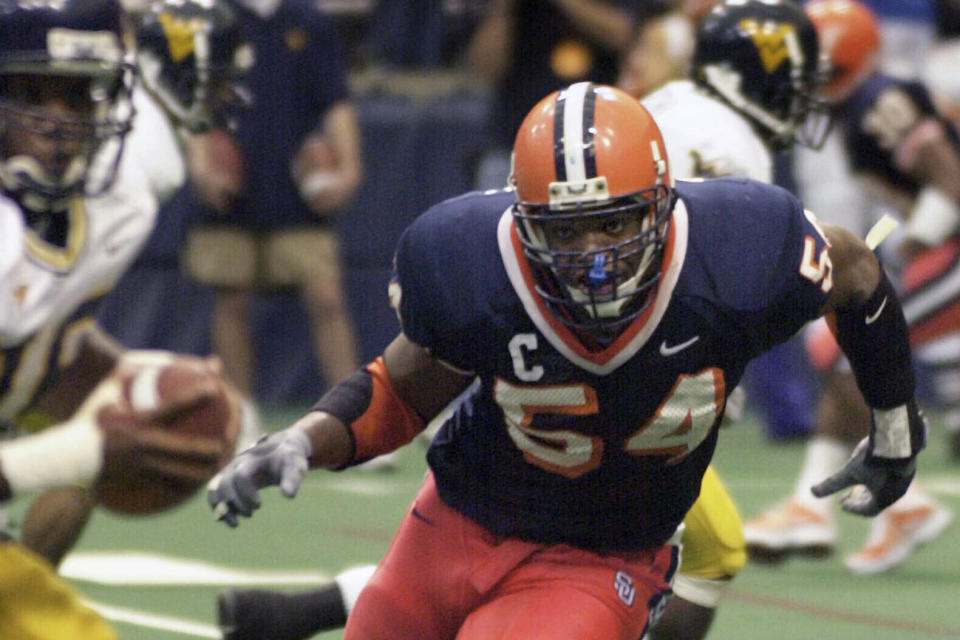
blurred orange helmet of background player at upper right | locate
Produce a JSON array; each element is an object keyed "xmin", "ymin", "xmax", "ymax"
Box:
[{"xmin": 804, "ymin": 0, "xmax": 880, "ymax": 101}]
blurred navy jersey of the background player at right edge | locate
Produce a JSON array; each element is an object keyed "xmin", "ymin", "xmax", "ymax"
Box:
[{"xmin": 840, "ymin": 73, "xmax": 958, "ymax": 195}]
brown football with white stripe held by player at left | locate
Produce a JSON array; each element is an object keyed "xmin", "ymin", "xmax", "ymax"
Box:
[{"xmin": 94, "ymin": 357, "xmax": 240, "ymax": 514}]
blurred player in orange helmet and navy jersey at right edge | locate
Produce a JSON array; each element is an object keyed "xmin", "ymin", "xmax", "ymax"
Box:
[{"xmin": 745, "ymin": 0, "xmax": 960, "ymax": 573}]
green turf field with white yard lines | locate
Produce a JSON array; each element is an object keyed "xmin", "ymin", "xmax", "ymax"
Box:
[{"xmin": 12, "ymin": 412, "xmax": 960, "ymax": 640}]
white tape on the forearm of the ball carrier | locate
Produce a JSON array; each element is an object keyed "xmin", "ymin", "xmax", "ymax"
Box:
[{"xmin": 0, "ymin": 416, "xmax": 103, "ymax": 496}]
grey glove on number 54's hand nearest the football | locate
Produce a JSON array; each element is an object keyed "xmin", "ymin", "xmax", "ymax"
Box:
[{"xmin": 207, "ymin": 429, "xmax": 312, "ymax": 527}]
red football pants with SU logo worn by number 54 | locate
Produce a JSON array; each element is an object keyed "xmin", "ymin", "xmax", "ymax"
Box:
[{"xmin": 344, "ymin": 474, "xmax": 678, "ymax": 640}]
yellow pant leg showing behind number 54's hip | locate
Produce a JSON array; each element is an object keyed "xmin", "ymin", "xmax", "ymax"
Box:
[{"xmin": 673, "ymin": 466, "xmax": 747, "ymax": 607}]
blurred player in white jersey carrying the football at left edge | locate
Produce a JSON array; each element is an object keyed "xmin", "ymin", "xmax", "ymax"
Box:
[{"xmin": 0, "ymin": 0, "xmax": 239, "ymax": 639}]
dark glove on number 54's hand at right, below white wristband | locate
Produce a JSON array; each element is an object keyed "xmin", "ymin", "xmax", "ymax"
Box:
[{"xmin": 811, "ymin": 438, "xmax": 917, "ymax": 516}]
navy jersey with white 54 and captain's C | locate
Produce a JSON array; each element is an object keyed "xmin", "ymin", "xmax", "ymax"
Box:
[{"xmin": 393, "ymin": 178, "xmax": 832, "ymax": 549}]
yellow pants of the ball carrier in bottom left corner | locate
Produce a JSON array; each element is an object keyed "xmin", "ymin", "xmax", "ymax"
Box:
[{"xmin": 0, "ymin": 542, "xmax": 117, "ymax": 640}]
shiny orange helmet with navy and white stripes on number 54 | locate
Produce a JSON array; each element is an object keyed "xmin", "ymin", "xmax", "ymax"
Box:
[{"xmin": 510, "ymin": 82, "xmax": 673, "ymax": 342}]
